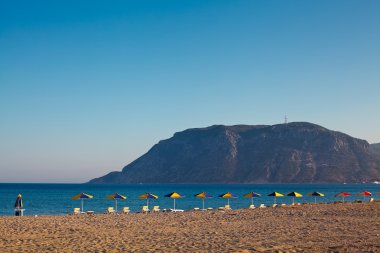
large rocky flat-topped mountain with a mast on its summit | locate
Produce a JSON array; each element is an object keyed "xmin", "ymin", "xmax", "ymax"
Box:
[{"xmin": 89, "ymin": 122, "xmax": 380, "ymax": 184}]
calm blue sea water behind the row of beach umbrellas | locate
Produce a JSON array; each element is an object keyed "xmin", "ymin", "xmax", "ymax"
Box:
[{"xmin": 0, "ymin": 184, "xmax": 380, "ymax": 216}]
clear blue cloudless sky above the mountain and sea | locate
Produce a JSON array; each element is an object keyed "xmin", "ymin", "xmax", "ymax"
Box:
[{"xmin": 0, "ymin": 0, "xmax": 380, "ymax": 182}]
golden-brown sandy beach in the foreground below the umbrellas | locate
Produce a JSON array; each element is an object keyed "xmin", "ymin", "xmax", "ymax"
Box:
[{"xmin": 0, "ymin": 202, "xmax": 380, "ymax": 252}]
